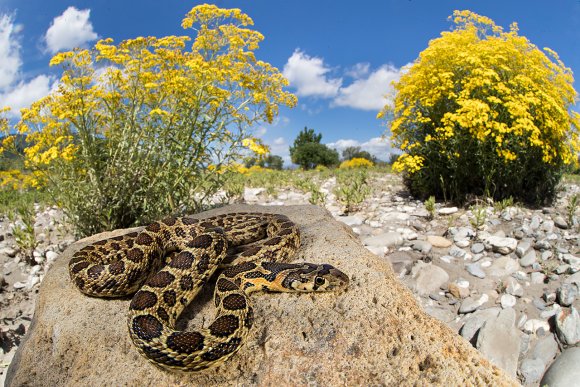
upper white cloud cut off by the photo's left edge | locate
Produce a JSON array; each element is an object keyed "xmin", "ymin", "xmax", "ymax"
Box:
[{"xmin": 0, "ymin": 15, "xmax": 22, "ymax": 89}]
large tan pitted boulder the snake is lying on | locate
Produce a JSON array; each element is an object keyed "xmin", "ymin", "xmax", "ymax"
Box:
[{"xmin": 6, "ymin": 205, "xmax": 517, "ymax": 386}]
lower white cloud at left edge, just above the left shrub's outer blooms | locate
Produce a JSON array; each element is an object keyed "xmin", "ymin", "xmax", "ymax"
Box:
[{"xmin": 0, "ymin": 75, "xmax": 52, "ymax": 117}]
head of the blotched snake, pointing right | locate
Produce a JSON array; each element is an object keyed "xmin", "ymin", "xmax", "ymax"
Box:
[{"xmin": 282, "ymin": 263, "xmax": 349, "ymax": 292}]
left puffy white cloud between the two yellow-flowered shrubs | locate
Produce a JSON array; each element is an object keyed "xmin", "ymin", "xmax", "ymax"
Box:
[{"xmin": 283, "ymin": 50, "xmax": 342, "ymax": 98}]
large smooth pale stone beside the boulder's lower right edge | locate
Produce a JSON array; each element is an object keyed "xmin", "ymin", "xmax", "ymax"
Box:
[{"xmin": 477, "ymin": 308, "xmax": 520, "ymax": 377}]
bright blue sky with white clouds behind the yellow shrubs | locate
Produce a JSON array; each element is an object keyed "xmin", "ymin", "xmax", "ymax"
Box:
[{"xmin": 0, "ymin": 0, "xmax": 580, "ymax": 165}]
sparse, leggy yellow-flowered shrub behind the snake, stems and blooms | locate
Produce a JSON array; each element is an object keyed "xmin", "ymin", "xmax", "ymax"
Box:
[{"xmin": 3, "ymin": 4, "xmax": 296, "ymax": 235}]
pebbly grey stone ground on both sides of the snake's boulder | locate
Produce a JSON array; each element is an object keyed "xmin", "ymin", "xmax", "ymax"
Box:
[{"xmin": 0, "ymin": 175, "xmax": 580, "ymax": 385}]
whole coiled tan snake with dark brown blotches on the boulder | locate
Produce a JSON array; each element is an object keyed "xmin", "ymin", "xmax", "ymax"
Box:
[{"xmin": 69, "ymin": 212, "xmax": 349, "ymax": 372}]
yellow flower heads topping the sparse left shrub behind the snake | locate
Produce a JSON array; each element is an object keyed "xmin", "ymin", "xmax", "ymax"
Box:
[{"xmin": 5, "ymin": 4, "xmax": 297, "ymax": 192}]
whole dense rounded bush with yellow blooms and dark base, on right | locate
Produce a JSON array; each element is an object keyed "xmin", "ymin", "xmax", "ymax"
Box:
[{"xmin": 379, "ymin": 11, "xmax": 580, "ymax": 204}]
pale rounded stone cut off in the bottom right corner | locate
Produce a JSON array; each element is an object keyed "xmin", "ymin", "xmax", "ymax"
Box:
[{"xmin": 540, "ymin": 347, "xmax": 580, "ymax": 387}]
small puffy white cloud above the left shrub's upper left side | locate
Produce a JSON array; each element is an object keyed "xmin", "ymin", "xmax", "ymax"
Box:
[{"xmin": 45, "ymin": 7, "xmax": 98, "ymax": 54}]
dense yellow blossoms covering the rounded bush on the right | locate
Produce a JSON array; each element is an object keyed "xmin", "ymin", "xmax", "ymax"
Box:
[{"xmin": 378, "ymin": 11, "xmax": 580, "ymax": 173}]
